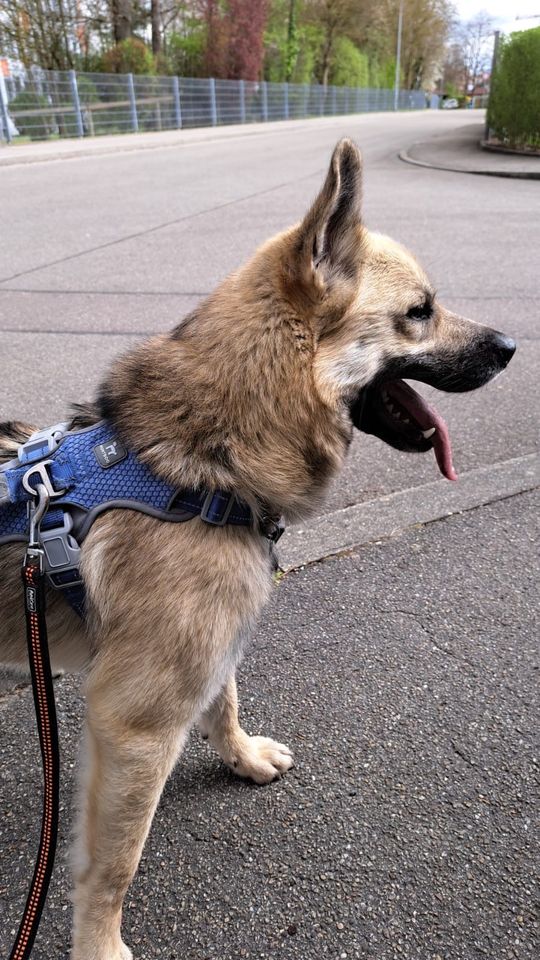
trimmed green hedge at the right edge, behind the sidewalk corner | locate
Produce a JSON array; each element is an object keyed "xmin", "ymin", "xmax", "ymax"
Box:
[{"xmin": 488, "ymin": 27, "xmax": 540, "ymax": 148}]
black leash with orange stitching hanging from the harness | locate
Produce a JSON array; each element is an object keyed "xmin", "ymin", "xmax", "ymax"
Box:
[{"xmin": 9, "ymin": 548, "xmax": 60, "ymax": 960}]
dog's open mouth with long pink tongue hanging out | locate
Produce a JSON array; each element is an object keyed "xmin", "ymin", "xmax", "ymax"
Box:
[{"xmin": 351, "ymin": 380, "xmax": 457, "ymax": 480}]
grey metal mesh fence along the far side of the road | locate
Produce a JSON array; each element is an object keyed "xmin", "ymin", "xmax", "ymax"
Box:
[{"xmin": 0, "ymin": 69, "xmax": 437, "ymax": 143}]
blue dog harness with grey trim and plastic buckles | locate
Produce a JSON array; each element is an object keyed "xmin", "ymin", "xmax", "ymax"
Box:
[{"xmin": 0, "ymin": 421, "xmax": 283, "ymax": 617}]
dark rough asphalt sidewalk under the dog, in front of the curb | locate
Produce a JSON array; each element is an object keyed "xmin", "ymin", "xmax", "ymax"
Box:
[{"xmin": 0, "ymin": 493, "xmax": 540, "ymax": 960}]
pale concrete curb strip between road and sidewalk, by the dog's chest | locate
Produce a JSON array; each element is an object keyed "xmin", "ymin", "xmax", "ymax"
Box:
[{"xmin": 279, "ymin": 453, "xmax": 540, "ymax": 571}]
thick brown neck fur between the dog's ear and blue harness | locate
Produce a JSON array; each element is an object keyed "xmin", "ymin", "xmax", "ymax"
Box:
[{"xmin": 95, "ymin": 235, "xmax": 352, "ymax": 520}]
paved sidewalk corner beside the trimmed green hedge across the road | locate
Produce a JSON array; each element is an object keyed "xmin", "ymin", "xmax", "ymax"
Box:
[{"xmin": 400, "ymin": 119, "xmax": 540, "ymax": 180}]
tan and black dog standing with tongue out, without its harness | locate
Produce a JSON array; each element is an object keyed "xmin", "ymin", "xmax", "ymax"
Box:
[{"xmin": 0, "ymin": 139, "xmax": 515, "ymax": 960}]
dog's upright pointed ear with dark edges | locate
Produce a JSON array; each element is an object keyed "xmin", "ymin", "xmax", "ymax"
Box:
[{"xmin": 299, "ymin": 139, "xmax": 362, "ymax": 280}]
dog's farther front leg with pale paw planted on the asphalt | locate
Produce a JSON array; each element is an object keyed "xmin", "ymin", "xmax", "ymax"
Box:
[{"xmin": 199, "ymin": 676, "xmax": 293, "ymax": 783}]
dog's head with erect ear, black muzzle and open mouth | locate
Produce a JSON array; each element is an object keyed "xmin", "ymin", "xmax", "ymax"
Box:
[{"xmin": 287, "ymin": 140, "xmax": 516, "ymax": 479}]
